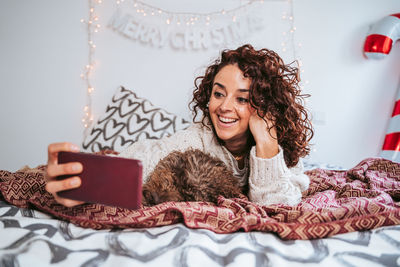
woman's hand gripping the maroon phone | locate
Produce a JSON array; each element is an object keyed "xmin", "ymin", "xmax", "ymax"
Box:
[{"xmin": 46, "ymin": 143, "xmax": 84, "ymax": 207}]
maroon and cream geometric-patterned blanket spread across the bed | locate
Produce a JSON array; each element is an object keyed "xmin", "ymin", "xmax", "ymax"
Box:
[{"xmin": 0, "ymin": 158, "xmax": 400, "ymax": 239}]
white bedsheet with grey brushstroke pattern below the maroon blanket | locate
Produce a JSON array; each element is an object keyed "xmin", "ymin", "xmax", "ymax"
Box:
[{"xmin": 0, "ymin": 201, "xmax": 400, "ymax": 267}]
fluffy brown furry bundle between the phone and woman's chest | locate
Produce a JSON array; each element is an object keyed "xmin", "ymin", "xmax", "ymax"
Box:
[{"xmin": 142, "ymin": 149, "xmax": 245, "ymax": 206}]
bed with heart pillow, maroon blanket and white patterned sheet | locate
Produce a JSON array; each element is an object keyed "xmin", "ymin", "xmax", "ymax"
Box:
[{"xmin": 0, "ymin": 87, "xmax": 400, "ymax": 266}]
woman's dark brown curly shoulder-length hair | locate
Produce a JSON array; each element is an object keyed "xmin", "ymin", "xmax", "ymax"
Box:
[{"xmin": 189, "ymin": 44, "xmax": 314, "ymax": 167}]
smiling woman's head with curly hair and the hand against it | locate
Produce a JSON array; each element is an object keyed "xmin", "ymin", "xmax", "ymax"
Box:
[{"xmin": 191, "ymin": 45, "xmax": 313, "ymax": 167}]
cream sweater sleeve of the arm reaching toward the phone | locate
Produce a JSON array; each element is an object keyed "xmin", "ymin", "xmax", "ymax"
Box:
[{"xmin": 115, "ymin": 126, "xmax": 203, "ymax": 183}]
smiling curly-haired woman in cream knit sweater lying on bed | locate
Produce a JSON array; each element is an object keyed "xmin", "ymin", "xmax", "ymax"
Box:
[{"xmin": 46, "ymin": 45, "xmax": 313, "ymax": 207}]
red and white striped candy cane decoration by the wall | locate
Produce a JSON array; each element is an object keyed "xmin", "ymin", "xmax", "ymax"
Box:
[{"xmin": 364, "ymin": 13, "xmax": 400, "ymax": 162}]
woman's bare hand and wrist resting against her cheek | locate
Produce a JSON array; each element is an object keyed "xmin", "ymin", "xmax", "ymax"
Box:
[{"xmin": 249, "ymin": 110, "xmax": 279, "ymax": 158}]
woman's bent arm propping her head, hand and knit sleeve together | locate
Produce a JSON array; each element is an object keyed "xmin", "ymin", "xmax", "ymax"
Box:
[{"xmin": 245, "ymin": 110, "xmax": 309, "ymax": 205}]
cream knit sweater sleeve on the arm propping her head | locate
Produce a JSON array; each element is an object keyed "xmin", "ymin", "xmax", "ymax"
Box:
[{"xmin": 249, "ymin": 147, "xmax": 310, "ymax": 205}]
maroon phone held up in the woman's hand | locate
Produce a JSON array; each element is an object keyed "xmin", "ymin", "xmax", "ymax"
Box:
[{"xmin": 57, "ymin": 152, "xmax": 142, "ymax": 209}]
